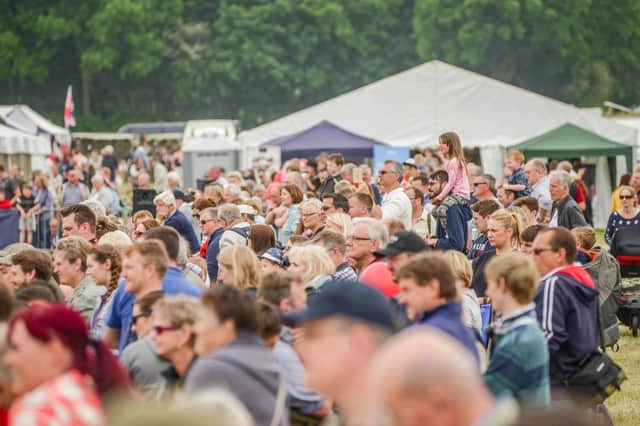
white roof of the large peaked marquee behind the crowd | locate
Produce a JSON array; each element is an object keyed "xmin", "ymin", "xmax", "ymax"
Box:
[{"xmin": 240, "ymin": 61, "xmax": 637, "ymax": 228}]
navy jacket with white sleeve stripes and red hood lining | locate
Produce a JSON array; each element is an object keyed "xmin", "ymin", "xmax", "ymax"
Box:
[{"xmin": 535, "ymin": 265, "xmax": 600, "ymax": 384}]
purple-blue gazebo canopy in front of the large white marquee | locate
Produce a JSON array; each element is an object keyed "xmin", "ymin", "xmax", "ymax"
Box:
[{"xmin": 264, "ymin": 120, "xmax": 387, "ymax": 161}]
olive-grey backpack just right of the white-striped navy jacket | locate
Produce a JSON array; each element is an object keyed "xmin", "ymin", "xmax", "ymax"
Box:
[{"xmin": 584, "ymin": 247, "xmax": 622, "ymax": 347}]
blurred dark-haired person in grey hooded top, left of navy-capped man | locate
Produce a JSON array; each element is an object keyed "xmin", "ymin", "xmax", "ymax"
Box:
[{"xmin": 184, "ymin": 286, "xmax": 289, "ymax": 426}]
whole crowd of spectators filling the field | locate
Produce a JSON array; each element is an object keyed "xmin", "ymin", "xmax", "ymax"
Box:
[{"xmin": 0, "ymin": 132, "xmax": 640, "ymax": 426}]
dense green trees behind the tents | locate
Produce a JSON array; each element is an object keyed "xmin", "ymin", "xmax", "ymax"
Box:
[{"xmin": 0, "ymin": 0, "xmax": 640, "ymax": 131}]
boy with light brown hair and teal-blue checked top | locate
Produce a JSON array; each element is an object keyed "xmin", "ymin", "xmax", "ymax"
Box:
[{"xmin": 484, "ymin": 252, "xmax": 550, "ymax": 407}]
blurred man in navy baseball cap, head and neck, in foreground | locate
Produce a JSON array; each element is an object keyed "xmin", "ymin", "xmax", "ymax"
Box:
[{"xmin": 283, "ymin": 282, "xmax": 395, "ymax": 424}]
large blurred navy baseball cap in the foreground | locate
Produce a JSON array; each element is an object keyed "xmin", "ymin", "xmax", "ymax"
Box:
[{"xmin": 282, "ymin": 281, "xmax": 396, "ymax": 330}]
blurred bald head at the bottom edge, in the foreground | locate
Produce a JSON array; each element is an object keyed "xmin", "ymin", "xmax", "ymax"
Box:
[{"xmin": 370, "ymin": 328, "xmax": 493, "ymax": 426}]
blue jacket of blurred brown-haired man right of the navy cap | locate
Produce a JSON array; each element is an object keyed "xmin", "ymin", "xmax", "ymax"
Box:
[{"xmin": 415, "ymin": 302, "xmax": 480, "ymax": 363}]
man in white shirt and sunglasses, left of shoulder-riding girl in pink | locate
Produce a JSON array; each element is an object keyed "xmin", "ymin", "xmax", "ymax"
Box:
[{"xmin": 378, "ymin": 160, "xmax": 412, "ymax": 231}]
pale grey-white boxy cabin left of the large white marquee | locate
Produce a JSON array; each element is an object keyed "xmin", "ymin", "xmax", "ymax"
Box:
[{"xmin": 182, "ymin": 137, "xmax": 242, "ymax": 188}]
